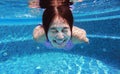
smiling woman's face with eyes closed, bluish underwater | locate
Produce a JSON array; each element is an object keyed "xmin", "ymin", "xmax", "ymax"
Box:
[{"xmin": 48, "ymin": 17, "xmax": 71, "ymax": 48}]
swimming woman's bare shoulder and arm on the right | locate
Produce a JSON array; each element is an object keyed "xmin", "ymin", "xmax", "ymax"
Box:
[{"xmin": 72, "ymin": 26, "xmax": 89, "ymax": 44}]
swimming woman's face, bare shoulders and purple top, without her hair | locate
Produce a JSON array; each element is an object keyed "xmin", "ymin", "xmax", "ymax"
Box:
[{"xmin": 33, "ymin": 18, "xmax": 89, "ymax": 48}]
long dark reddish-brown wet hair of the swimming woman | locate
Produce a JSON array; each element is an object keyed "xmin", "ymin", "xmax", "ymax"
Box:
[{"xmin": 40, "ymin": 0, "xmax": 73, "ymax": 40}]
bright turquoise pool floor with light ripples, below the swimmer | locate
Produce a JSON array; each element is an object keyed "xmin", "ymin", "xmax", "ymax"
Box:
[{"xmin": 0, "ymin": 52, "xmax": 120, "ymax": 74}]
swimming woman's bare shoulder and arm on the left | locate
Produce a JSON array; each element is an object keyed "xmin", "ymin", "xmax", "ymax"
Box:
[{"xmin": 33, "ymin": 25, "xmax": 46, "ymax": 43}]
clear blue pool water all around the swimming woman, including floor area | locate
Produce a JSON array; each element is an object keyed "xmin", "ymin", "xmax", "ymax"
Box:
[{"xmin": 0, "ymin": 0, "xmax": 120, "ymax": 74}]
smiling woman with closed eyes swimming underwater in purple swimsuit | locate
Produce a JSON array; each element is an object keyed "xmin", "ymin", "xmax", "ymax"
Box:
[{"xmin": 33, "ymin": 0, "xmax": 89, "ymax": 48}]
